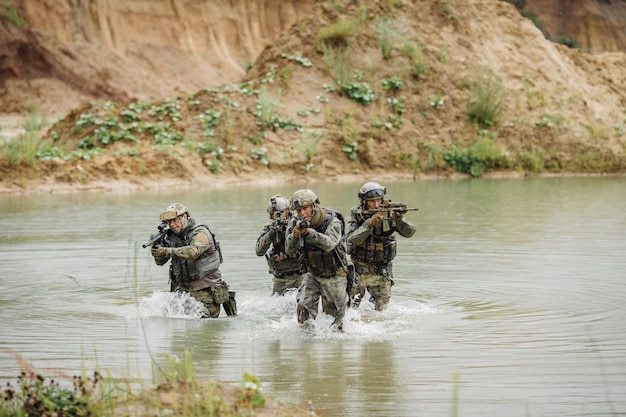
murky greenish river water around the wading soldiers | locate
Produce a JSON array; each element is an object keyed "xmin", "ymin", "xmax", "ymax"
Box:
[{"xmin": 0, "ymin": 177, "xmax": 626, "ymax": 417}]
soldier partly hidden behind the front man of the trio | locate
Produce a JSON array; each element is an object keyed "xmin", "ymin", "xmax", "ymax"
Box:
[{"xmin": 256, "ymin": 194, "xmax": 302, "ymax": 295}]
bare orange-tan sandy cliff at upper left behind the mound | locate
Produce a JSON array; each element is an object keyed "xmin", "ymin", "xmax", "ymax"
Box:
[{"xmin": 0, "ymin": 0, "xmax": 313, "ymax": 116}]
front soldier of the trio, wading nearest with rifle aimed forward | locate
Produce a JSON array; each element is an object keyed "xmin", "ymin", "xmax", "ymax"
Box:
[{"xmin": 285, "ymin": 189, "xmax": 349, "ymax": 331}]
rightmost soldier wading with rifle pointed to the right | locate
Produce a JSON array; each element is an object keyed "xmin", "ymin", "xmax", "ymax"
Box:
[{"xmin": 347, "ymin": 182, "xmax": 417, "ymax": 311}]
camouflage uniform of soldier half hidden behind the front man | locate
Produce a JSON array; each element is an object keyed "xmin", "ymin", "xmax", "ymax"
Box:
[{"xmin": 256, "ymin": 220, "xmax": 302, "ymax": 295}]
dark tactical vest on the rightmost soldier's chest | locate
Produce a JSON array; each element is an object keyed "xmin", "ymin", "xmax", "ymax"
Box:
[{"xmin": 350, "ymin": 218, "xmax": 396, "ymax": 265}]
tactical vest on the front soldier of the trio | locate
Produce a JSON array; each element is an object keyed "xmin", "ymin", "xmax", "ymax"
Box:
[{"xmin": 302, "ymin": 209, "xmax": 346, "ymax": 278}]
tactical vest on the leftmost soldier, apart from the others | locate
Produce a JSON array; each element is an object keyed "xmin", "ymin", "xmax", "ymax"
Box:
[{"xmin": 171, "ymin": 224, "xmax": 223, "ymax": 283}]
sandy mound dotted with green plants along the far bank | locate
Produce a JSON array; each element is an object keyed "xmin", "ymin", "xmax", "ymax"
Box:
[{"xmin": 0, "ymin": 0, "xmax": 626, "ymax": 190}]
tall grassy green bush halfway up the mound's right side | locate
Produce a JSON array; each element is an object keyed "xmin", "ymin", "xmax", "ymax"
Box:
[{"xmin": 466, "ymin": 69, "xmax": 504, "ymax": 126}]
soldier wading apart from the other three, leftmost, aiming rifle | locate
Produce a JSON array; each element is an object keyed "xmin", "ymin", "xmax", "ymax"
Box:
[{"xmin": 151, "ymin": 203, "xmax": 237, "ymax": 317}]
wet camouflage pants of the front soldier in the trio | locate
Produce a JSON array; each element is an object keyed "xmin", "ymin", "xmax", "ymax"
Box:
[{"xmin": 296, "ymin": 271, "xmax": 348, "ymax": 329}]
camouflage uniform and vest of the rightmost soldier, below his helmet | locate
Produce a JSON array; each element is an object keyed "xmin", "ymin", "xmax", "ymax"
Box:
[{"xmin": 347, "ymin": 183, "xmax": 417, "ymax": 311}]
